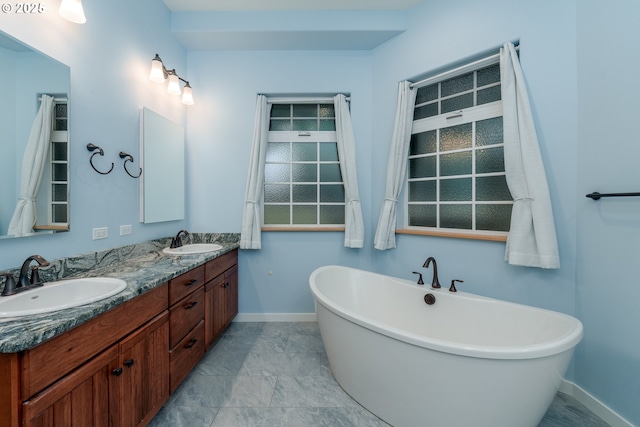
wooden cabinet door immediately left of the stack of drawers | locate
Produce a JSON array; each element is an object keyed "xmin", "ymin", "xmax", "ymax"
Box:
[{"xmin": 120, "ymin": 311, "xmax": 169, "ymax": 427}]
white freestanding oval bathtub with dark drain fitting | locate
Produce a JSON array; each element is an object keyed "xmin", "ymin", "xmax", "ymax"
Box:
[{"xmin": 309, "ymin": 266, "xmax": 582, "ymax": 427}]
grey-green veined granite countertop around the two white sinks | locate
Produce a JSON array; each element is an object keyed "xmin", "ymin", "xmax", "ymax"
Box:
[{"xmin": 0, "ymin": 233, "xmax": 239, "ymax": 353}]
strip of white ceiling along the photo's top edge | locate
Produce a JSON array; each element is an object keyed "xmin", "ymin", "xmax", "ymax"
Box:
[{"xmin": 164, "ymin": 0, "xmax": 423, "ymax": 12}]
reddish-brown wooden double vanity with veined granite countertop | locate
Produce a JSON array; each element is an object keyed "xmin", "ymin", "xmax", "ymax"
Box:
[{"xmin": 0, "ymin": 234, "xmax": 238, "ymax": 427}]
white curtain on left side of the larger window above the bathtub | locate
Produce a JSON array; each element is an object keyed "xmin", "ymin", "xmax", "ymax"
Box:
[{"xmin": 374, "ymin": 81, "xmax": 417, "ymax": 250}]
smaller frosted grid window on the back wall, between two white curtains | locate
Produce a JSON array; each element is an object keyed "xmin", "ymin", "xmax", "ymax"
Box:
[{"xmin": 263, "ymin": 103, "xmax": 345, "ymax": 228}]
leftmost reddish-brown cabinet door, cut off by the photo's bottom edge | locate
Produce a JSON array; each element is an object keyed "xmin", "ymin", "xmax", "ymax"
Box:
[{"xmin": 22, "ymin": 345, "xmax": 119, "ymax": 427}]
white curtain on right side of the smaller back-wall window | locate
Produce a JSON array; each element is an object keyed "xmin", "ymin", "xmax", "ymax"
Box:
[{"xmin": 333, "ymin": 94, "xmax": 364, "ymax": 248}]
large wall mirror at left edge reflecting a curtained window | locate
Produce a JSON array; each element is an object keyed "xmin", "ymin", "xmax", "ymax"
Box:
[{"xmin": 0, "ymin": 31, "xmax": 70, "ymax": 238}]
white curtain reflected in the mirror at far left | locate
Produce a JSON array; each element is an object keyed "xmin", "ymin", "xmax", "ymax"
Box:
[{"xmin": 7, "ymin": 95, "xmax": 54, "ymax": 236}]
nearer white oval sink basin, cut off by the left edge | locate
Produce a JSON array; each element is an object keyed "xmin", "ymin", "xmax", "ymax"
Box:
[{"xmin": 0, "ymin": 277, "xmax": 127, "ymax": 317}]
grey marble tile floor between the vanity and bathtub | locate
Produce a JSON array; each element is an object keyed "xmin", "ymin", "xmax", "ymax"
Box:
[{"xmin": 149, "ymin": 322, "xmax": 608, "ymax": 427}]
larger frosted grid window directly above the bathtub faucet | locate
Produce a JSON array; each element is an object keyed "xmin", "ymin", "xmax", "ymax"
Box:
[{"xmin": 405, "ymin": 63, "xmax": 513, "ymax": 235}]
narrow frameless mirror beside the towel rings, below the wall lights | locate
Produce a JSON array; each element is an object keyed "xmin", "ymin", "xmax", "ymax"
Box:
[{"xmin": 140, "ymin": 108, "xmax": 185, "ymax": 223}]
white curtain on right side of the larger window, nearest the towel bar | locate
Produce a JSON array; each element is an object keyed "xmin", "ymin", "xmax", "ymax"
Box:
[{"xmin": 500, "ymin": 43, "xmax": 560, "ymax": 268}]
